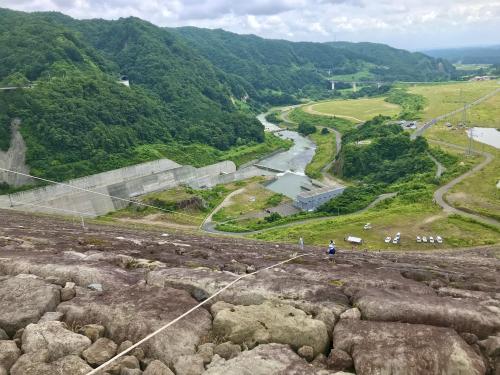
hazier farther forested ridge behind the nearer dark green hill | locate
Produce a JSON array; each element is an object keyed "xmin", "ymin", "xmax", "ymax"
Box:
[{"xmin": 173, "ymin": 27, "xmax": 455, "ymax": 104}]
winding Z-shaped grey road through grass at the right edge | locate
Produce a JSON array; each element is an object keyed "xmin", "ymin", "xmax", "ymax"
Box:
[{"xmin": 431, "ymin": 140, "xmax": 500, "ymax": 226}]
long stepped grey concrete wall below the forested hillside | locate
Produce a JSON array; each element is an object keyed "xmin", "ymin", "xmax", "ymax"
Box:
[{"xmin": 0, "ymin": 159, "xmax": 242, "ymax": 216}]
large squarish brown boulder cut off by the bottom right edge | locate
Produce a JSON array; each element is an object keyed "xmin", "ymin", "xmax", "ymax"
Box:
[{"xmin": 333, "ymin": 319, "xmax": 486, "ymax": 375}]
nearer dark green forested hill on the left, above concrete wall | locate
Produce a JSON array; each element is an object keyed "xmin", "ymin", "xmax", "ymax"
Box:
[{"xmin": 0, "ymin": 10, "xmax": 264, "ymax": 179}]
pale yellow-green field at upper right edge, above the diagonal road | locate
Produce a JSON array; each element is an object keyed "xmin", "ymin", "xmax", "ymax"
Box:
[{"xmin": 408, "ymin": 81, "xmax": 500, "ymax": 120}]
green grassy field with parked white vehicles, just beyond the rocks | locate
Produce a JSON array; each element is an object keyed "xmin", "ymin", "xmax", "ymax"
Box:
[{"xmin": 253, "ymin": 204, "xmax": 500, "ymax": 250}]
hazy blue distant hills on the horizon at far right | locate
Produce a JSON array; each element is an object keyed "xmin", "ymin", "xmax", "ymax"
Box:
[{"xmin": 425, "ymin": 45, "xmax": 500, "ymax": 64}]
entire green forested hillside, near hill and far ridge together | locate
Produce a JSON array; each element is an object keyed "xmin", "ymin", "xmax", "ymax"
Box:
[{"xmin": 0, "ymin": 9, "xmax": 454, "ymax": 179}]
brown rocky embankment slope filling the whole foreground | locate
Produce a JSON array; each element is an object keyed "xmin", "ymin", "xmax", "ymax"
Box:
[{"xmin": 0, "ymin": 211, "xmax": 500, "ymax": 375}]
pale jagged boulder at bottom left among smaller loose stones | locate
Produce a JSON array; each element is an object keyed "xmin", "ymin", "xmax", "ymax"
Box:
[{"xmin": 22, "ymin": 321, "xmax": 91, "ymax": 361}]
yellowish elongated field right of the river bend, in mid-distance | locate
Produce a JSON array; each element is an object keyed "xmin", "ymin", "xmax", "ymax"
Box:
[{"xmin": 304, "ymin": 98, "xmax": 401, "ymax": 122}]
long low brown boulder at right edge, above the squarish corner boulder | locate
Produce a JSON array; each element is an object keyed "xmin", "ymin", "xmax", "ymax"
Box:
[{"xmin": 354, "ymin": 289, "xmax": 500, "ymax": 338}]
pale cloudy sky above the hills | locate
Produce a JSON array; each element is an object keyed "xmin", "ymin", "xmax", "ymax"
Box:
[{"xmin": 0, "ymin": 0, "xmax": 500, "ymax": 50}]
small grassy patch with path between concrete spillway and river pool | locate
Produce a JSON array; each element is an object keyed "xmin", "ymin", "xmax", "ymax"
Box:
[{"xmin": 213, "ymin": 177, "xmax": 290, "ymax": 222}]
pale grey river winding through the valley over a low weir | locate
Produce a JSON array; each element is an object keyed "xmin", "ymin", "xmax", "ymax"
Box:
[{"xmin": 257, "ymin": 113, "xmax": 316, "ymax": 199}]
